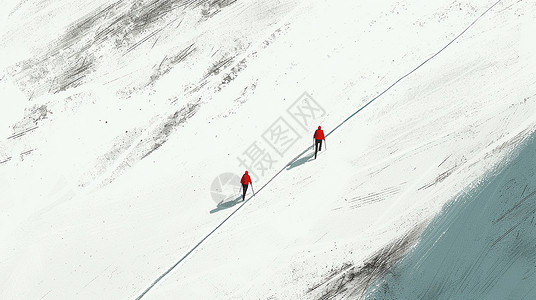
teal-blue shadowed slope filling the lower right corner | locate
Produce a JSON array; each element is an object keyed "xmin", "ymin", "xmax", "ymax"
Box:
[{"xmin": 366, "ymin": 133, "xmax": 536, "ymax": 299}]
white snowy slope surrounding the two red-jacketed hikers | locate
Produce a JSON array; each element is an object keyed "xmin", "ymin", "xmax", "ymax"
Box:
[{"xmin": 0, "ymin": 0, "xmax": 536, "ymax": 299}]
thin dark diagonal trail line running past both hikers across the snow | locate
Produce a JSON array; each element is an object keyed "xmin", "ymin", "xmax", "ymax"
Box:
[{"xmin": 136, "ymin": 0, "xmax": 502, "ymax": 300}]
